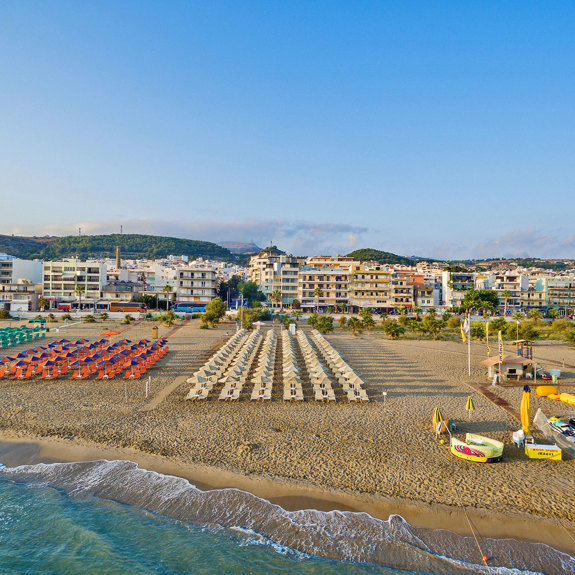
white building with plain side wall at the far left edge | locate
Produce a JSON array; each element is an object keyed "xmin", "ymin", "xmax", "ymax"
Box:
[{"xmin": 0, "ymin": 254, "xmax": 42, "ymax": 312}]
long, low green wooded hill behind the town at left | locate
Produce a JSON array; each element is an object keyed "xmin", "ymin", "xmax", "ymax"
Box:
[{"xmin": 0, "ymin": 234, "xmax": 240, "ymax": 261}]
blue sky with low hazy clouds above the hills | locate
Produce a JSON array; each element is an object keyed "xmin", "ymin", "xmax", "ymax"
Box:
[{"xmin": 0, "ymin": 0, "xmax": 575, "ymax": 258}]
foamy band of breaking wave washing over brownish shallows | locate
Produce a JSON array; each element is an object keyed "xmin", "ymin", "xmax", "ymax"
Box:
[{"xmin": 1, "ymin": 460, "xmax": 575, "ymax": 575}]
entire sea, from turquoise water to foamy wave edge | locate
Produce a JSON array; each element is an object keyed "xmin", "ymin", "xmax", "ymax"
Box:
[{"xmin": 0, "ymin": 460, "xmax": 575, "ymax": 575}]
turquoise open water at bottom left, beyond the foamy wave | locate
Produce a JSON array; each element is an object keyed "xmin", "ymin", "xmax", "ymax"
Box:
[{"xmin": 0, "ymin": 478, "xmax": 392, "ymax": 575}]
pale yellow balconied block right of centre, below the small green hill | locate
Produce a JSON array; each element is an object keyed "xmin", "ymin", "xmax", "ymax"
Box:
[{"xmin": 349, "ymin": 263, "xmax": 393, "ymax": 311}]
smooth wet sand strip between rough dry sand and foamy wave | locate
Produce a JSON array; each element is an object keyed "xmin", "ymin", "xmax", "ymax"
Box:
[{"xmin": 0, "ymin": 431, "xmax": 575, "ymax": 556}]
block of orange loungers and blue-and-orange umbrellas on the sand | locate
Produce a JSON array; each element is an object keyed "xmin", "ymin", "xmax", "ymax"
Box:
[{"xmin": 0, "ymin": 338, "xmax": 168, "ymax": 379}]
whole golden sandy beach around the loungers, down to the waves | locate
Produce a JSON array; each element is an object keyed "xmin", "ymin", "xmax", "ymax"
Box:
[{"xmin": 0, "ymin": 321, "xmax": 575, "ymax": 554}]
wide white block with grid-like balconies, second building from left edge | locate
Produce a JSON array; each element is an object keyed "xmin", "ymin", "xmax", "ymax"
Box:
[{"xmin": 42, "ymin": 259, "xmax": 107, "ymax": 307}]
